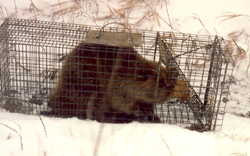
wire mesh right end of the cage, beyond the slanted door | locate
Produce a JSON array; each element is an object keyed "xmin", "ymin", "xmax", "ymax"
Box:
[{"xmin": 161, "ymin": 33, "xmax": 233, "ymax": 130}]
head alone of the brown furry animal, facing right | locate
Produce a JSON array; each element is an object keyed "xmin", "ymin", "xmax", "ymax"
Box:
[{"xmin": 116, "ymin": 60, "xmax": 178, "ymax": 103}]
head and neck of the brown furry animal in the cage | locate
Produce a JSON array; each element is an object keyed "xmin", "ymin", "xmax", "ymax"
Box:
[{"xmin": 112, "ymin": 49, "xmax": 182, "ymax": 103}]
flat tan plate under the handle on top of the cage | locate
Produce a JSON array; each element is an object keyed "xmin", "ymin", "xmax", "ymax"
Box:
[{"xmin": 84, "ymin": 30, "xmax": 142, "ymax": 47}]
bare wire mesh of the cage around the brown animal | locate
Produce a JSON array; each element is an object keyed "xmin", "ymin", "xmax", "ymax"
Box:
[{"xmin": 0, "ymin": 19, "xmax": 233, "ymax": 130}]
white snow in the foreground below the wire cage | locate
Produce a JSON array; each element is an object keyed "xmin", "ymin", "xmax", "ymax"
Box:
[{"xmin": 0, "ymin": 112, "xmax": 250, "ymax": 156}]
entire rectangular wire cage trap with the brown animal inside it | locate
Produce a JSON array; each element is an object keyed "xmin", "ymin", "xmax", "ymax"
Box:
[{"xmin": 0, "ymin": 19, "xmax": 233, "ymax": 130}]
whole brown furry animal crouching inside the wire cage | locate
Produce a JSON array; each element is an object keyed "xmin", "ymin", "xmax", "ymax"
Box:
[{"xmin": 43, "ymin": 43, "xmax": 179, "ymax": 123}]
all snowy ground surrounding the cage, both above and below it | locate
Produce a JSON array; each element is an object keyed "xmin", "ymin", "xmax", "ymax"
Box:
[{"xmin": 0, "ymin": 0, "xmax": 250, "ymax": 156}]
